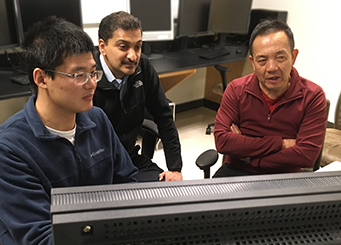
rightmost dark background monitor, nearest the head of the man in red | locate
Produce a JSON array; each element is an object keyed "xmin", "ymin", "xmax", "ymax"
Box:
[{"xmin": 208, "ymin": 0, "xmax": 252, "ymax": 34}]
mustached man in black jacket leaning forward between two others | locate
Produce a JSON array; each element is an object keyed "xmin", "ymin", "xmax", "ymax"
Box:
[{"xmin": 94, "ymin": 11, "xmax": 182, "ymax": 182}]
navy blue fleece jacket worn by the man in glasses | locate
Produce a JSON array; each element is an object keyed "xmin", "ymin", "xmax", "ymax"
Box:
[{"xmin": 0, "ymin": 95, "xmax": 137, "ymax": 245}]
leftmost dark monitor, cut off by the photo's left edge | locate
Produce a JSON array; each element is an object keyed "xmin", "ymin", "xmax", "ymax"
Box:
[{"xmin": 0, "ymin": 0, "xmax": 19, "ymax": 49}]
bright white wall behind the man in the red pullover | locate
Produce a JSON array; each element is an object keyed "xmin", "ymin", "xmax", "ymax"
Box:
[{"xmin": 252, "ymin": 0, "xmax": 341, "ymax": 122}]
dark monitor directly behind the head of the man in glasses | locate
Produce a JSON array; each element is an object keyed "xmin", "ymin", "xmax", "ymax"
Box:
[{"xmin": 17, "ymin": 0, "xmax": 83, "ymax": 41}]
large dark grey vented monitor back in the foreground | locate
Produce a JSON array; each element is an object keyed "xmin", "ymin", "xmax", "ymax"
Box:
[{"xmin": 51, "ymin": 171, "xmax": 341, "ymax": 245}]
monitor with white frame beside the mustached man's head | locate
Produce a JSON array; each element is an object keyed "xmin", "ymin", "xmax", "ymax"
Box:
[{"xmin": 130, "ymin": 0, "xmax": 174, "ymax": 41}]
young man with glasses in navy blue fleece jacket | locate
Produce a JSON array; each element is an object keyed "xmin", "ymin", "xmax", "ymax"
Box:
[{"xmin": 0, "ymin": 17, "xmax": 137, "ymax": 244}]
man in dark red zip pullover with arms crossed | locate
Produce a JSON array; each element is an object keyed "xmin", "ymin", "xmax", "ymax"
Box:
[{"xmin": 213, "ymin": 20, "xmax": 327, "ymax": 177}]
